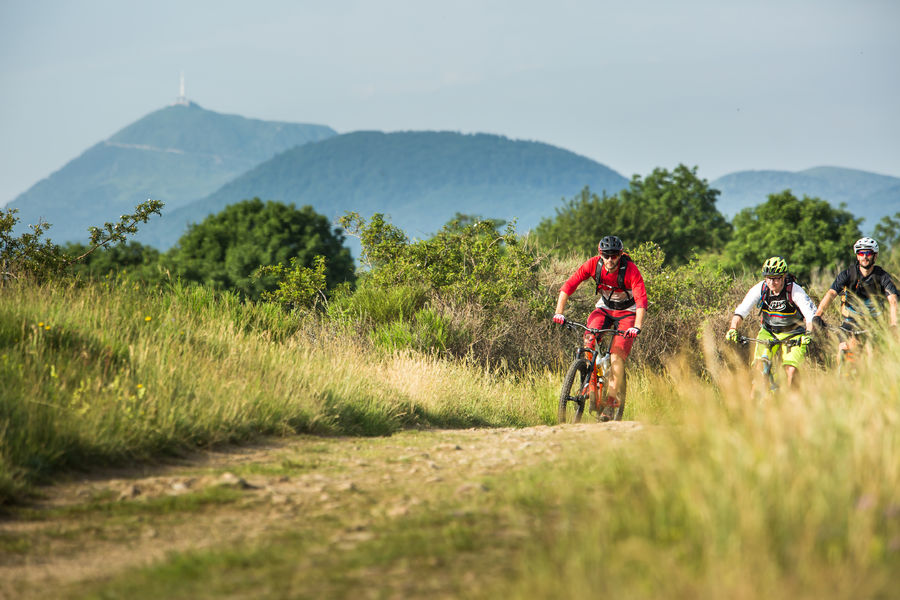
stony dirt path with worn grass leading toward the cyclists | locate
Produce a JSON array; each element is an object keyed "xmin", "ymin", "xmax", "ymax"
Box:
[{"xmin": 0, "ymin": 422, "xmax": 642, "ymax": 598}]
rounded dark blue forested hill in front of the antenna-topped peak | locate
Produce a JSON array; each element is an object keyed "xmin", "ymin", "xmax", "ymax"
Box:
[{"xmin": 138, "ymin": 131, "xmax": 628, "ymax": 248}]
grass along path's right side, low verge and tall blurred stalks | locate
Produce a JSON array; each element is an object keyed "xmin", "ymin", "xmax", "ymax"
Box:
[{"xmin": 77, "ymin": 336, "xmax": 900, "ymax": 600}]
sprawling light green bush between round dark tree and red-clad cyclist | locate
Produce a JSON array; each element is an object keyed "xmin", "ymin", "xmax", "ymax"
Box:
[{"xmin": 329, "ymin": 213, "xmax": 551, "ymax": 365}]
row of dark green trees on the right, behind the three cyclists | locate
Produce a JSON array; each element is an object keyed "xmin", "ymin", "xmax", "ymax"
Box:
[{"xmin": 535, "ymin": 165, "xmax": 900, "ymax": 278}]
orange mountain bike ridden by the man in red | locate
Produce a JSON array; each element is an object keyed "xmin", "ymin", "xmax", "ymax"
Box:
[{"xmin": 557, "ymin": 321, "xmax": 625, "ymax": 423}]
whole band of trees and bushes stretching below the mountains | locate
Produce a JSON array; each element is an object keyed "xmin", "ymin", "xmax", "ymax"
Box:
[{"xmin": 0, "ymin": 165, "xmax": 900, "ymax": 361}]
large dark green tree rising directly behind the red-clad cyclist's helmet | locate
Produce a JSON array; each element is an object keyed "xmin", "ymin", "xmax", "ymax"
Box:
[{"xmin": 535, "ymin": 165, "xmax": 731, "ymax": 265}]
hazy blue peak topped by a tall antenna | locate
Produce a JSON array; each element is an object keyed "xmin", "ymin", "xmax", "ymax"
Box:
[{"xmin": 9, "ymin": 104, "xmax": 335, "ymax": 242}]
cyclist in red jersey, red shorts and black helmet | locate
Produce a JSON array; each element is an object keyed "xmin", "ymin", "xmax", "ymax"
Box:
[{"xmin": 553, "ymin": 235, "xmax": 647, "ymax": 418}]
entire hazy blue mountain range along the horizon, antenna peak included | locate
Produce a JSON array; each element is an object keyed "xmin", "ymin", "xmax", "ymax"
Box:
[{"xmin": 8, "ymin": 103, "xmax": 900, "ymax": 249}]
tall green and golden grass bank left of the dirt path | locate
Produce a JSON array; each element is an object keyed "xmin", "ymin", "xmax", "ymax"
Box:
[{"xmin": 0, "ymin": 282, "xmax": 552, "ymax": 504}]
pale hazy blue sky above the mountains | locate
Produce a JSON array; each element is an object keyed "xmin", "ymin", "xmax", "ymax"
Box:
[{"xmin": 0, "ymin": 0, "xmax": 900, "ymax": 205}]
